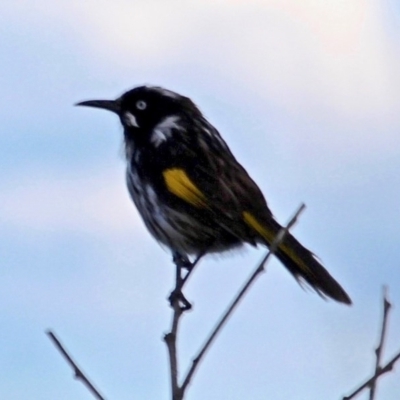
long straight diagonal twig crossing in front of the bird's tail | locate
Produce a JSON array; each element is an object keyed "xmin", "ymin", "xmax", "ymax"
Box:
[{"xmin": 181, "ymin": 204, "xmax": 305, "ymax": 398}]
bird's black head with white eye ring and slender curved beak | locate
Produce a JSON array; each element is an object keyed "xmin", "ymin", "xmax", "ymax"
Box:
[{"xmin": 76, "ymin": 86, "xmax": 201, "ymax": 145}]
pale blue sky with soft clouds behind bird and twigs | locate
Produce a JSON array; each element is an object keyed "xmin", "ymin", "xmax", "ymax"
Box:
[{"xmin": 0, "ymin": 0, "xmax": 400, "ymax": 400}]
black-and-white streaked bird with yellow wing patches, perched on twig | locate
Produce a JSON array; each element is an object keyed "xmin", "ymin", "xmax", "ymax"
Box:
[{"xmin": 76, "ymin": 85, "xmax": 351, "ymax": 304}]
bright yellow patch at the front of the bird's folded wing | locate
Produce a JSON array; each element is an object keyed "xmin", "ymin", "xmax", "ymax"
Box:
[{"xmin": 163, "ymin": 168, "xmax": 207, "ymax": 208}]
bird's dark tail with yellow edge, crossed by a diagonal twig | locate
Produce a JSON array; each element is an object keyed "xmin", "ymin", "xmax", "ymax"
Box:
[{"xmin": 244, "ymin": 213, "xmax": 351, "ymax": 304}]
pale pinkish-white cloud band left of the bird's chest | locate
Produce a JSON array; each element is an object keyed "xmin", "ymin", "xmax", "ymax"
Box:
[{"xmin": 0, "ymin": 170, "xmax": 142, "ymax": 234}]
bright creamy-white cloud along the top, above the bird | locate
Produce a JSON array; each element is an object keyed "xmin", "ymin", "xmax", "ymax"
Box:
[{"xmin": 56, "ymin": 0, "xmax": 400, "ymax": 122}]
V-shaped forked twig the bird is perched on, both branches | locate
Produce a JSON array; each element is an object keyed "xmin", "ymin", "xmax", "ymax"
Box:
[{"xmin": 164, "ymin": 204, "xmax": 305, "ymax": 400}]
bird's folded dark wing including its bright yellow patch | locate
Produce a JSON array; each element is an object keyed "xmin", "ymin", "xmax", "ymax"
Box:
[{"xmin": 157, "ymin": 120, "xmax": 276, "ymax": 242}]
